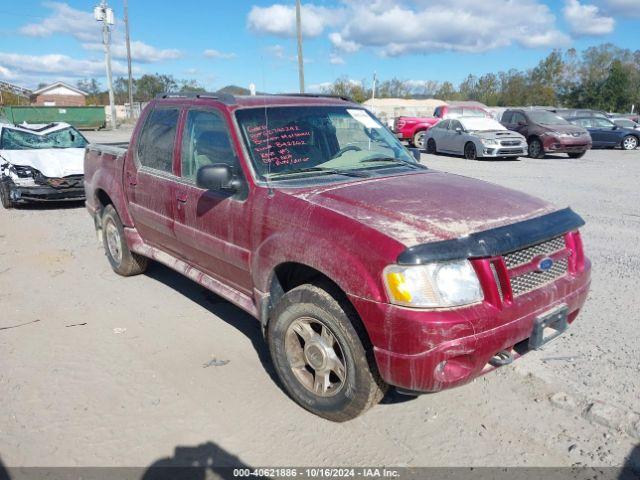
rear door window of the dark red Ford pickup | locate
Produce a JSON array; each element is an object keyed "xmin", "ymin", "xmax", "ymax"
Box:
[{"xmin": 137, "ymin": 108, "xmax": 180, "ymax": 173}]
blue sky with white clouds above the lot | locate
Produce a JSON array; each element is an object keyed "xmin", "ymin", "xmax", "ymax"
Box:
[{"xmin": 0, "ymin": 0, "xmax": 640, "ymax": 93}]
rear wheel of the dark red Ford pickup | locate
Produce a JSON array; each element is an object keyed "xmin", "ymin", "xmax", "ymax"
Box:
[{"xmin": 102, "ymin": 205, "xmax": 149, "ymax": 277}]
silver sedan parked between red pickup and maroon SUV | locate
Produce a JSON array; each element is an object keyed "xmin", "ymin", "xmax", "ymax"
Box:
[{"xmin": 426, "ymin": 117, "xmax": 527, "ymax": 160}]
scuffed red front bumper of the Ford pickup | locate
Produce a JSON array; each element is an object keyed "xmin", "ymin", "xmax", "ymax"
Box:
[{"xmin": 350, "ymin": 262, "xmax": 590, "ymax": 392}]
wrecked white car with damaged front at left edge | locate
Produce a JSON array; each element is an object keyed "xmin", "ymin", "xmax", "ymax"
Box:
[{"xmin": 0, "ymin": 123, "xmax": 88, "ymax": 208}]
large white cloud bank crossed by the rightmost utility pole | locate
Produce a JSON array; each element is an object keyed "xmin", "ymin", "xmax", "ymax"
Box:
[{"xmin": 248, "ymin": 0, "xmax": 572, "ymax": 56}]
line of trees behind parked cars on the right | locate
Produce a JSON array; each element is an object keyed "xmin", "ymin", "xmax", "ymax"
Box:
[{"xmin": 323, "ymin": 43, "xmax": 640, "ymax": 112}]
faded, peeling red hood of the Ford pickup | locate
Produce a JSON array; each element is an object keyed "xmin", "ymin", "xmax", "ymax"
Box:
[{"xmin": 292, "ymin": 171, "xmax": 557, "ymax": 247}]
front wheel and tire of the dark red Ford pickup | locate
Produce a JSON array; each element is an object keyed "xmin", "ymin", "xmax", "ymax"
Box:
[{"xmin": 267, "ymin": 284, "xmax": 387, "ymax": 422}]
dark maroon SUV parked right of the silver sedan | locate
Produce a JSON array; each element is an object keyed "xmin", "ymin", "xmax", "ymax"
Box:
[{"xmin": 502, "ymin": 109, "xmax": 591, "ymax": 158}]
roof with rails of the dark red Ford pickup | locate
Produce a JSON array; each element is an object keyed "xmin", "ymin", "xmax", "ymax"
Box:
[{"xmin": 156, "ymin": 93, "xmax": 355, "ymax": 108}]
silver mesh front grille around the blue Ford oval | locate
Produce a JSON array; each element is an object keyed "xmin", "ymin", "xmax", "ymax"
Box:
[{"xmin": 503, "ymin": 237, "xmax": 569, "ymax": 297}]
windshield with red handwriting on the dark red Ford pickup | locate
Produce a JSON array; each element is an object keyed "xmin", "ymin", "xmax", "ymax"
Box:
[{"xmin": 236, "ymin": 106, "xmax": 418, "ymax": 179}]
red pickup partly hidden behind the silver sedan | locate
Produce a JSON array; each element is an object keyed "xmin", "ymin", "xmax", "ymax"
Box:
[{"xmin": 393, "ymin": 105, "xmax": 492, "ymax": 150}]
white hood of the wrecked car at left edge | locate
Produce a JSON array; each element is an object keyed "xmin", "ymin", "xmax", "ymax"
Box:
[{"xmin": 0, "ymin": 148, "xmax": 84, "ymax": 178}]
